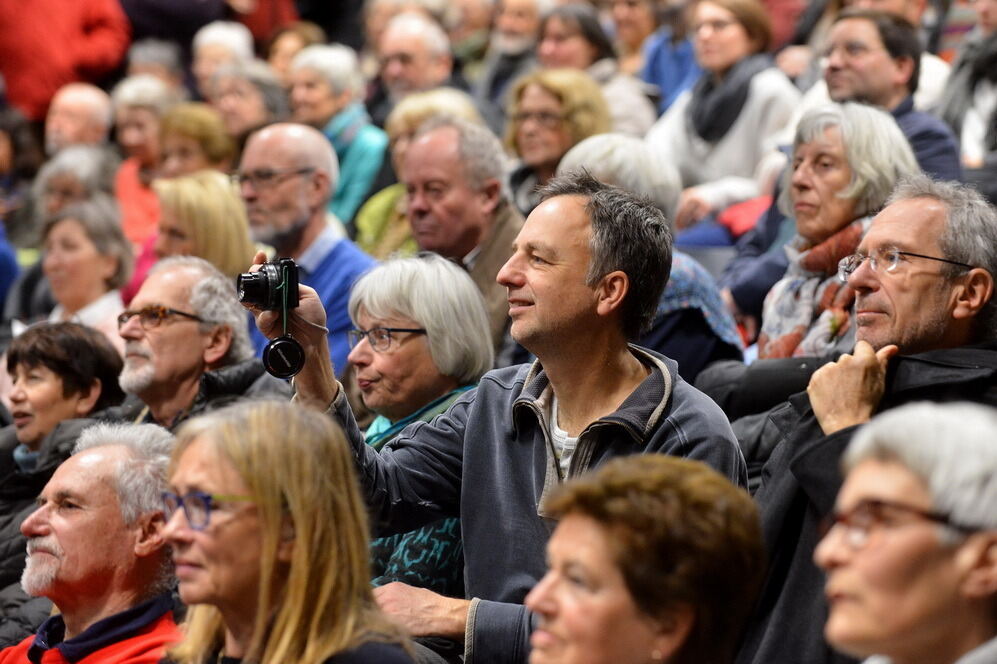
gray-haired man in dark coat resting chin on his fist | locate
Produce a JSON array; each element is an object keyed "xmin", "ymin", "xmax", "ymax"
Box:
[{"xmin": 734, "ymin": 176, "xmax": 997, "ymax": 664}]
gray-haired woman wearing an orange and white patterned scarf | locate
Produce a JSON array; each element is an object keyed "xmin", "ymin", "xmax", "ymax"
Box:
[{"xmin": 758, "ymin": 103, "xmax": 920, "ymax": 358}]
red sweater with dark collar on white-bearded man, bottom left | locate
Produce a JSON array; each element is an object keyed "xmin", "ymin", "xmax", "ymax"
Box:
[{"xmin": 0, "ymin": 595, "xmax": 183, "ymax": 664}]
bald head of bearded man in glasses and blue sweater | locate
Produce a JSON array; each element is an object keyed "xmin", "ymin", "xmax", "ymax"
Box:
[{"xmin": 239, "ymin": 123, "xmax": 339, "ymax": 258}]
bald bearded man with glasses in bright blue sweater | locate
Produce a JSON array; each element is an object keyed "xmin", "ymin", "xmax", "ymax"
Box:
[{"xmin": 238, "ymin": 123, "xmax": 374, "ymax": 367}]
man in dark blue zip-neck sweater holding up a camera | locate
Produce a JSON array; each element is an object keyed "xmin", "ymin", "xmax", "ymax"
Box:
[{"xmin": 257, "ymin": 170, "xmax": 745, "ymax": 661}]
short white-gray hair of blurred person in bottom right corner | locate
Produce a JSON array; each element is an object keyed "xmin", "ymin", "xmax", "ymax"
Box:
[{"xmin": 842, "ymin": 402, "xmax": 997, "ymax": 529}]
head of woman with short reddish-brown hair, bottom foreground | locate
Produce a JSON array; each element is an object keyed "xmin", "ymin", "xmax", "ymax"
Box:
[{"xmin": 526, "ymin": 455, "xmax": 765, "ymax": 664}]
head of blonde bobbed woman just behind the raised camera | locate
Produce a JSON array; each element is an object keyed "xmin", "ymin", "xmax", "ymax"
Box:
[{"xmin": 153, "ymin": 170, "xmax": 255, "ymax": 278}]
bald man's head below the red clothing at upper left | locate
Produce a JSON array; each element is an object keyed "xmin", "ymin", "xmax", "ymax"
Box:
[{"xmin": 45, "ymin": 83, "xmax": 113, "ymax": 155}]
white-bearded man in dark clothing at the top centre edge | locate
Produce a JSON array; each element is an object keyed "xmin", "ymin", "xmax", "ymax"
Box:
[{"xmin": 474, "ymin": 0, "xmax": 554, "ymax": 136}]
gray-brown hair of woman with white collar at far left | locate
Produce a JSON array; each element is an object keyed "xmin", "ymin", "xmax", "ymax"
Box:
[{"xmin": 42, "ymin": 193, "xmax": 133, "ymax": 290}]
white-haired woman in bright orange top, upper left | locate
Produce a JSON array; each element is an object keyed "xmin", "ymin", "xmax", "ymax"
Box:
[{"xmin": 111, "ymin": 74, "xmax": 179, "ymax": 247}]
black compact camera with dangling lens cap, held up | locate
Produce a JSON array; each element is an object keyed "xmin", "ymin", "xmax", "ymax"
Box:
[{"xmin": 235, "ymin": 258, "xmax": 305, "ymax": 378}]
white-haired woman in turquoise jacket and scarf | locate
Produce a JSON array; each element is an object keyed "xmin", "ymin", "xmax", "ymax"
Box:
[{"xmin": 290, "ymin": 44, "xmax": 388, "ymax": 225}]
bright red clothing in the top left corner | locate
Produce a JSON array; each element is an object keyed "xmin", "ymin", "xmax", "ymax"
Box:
[{"xmin": 0, "ymin": 0, "xmax": 131, "ymax": 120}]
